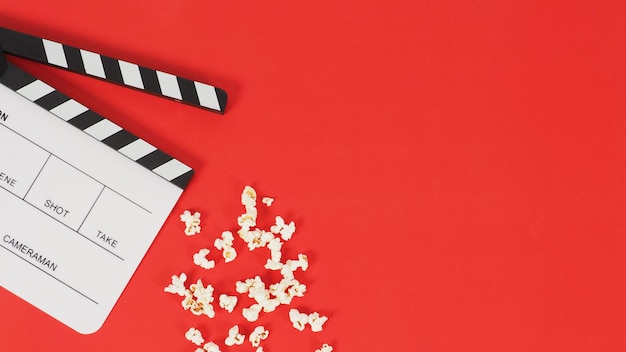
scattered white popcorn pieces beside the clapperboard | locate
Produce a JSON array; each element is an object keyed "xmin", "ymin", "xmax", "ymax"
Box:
[{"xmin": 164, "ymin": 186, "xmax": 333, "ymax": 352}]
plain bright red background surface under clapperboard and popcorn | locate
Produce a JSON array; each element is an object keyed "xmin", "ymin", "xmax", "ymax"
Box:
[{"xmin": 0, "ymin": 0, "xmax": 626, "ymax": 352}]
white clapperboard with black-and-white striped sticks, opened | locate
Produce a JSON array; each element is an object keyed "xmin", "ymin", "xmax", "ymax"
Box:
[{"xmin": 0, "ymin": 28, "xmax": 227, "ymax": 333}]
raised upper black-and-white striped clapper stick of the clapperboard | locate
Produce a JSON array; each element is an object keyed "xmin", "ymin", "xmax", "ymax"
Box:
[{"xmin": 0, "ymin": 27, "xmax": 228, "ymax": 114}]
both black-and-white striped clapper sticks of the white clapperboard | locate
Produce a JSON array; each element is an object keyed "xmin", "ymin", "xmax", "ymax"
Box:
[{"xmin": 0, "ymin": 27, "xmax": 227, "ymax": 189}]
